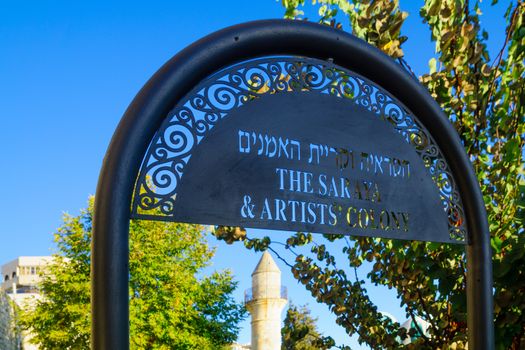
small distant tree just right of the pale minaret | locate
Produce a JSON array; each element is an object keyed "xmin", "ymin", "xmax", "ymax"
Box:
[{"xmin": 281, "ymin": 302, "xmax": 334, "ymax": 350}]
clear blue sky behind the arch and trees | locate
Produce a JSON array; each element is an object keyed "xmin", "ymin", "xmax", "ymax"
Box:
[{"xmin": 0, "ymin": 0, "xmax": 508, "ymax": 348}]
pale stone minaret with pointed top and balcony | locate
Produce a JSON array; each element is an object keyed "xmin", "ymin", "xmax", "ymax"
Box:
[{"xmin": 245, "ymin": 251, "xmax": 287, "ymax": 350}]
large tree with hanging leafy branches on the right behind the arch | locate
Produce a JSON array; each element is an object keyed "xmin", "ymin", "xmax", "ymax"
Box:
[{"xmin": 214, "ymin": 0, "xmax": 525, "ymax": 349}]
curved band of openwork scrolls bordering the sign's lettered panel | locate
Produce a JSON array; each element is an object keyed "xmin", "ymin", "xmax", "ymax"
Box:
[{"xmin": 132, "ymin": 57, "xmax": 466, "ymax": 242}]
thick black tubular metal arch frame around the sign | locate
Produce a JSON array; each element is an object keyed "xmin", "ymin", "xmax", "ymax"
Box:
[{"xmin": 92, "ymin": 20, "xmax": 494, "ymax": 350}]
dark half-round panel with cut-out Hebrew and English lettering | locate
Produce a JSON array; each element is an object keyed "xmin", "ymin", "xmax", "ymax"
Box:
[{"xmin": 163, "ymin": 92, "xmax": 450, "ymax": 242}]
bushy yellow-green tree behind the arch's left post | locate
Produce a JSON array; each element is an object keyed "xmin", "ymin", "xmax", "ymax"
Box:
[{"xmin": 22, "ymin": 200, "xmax": 245, "ymax": 349}]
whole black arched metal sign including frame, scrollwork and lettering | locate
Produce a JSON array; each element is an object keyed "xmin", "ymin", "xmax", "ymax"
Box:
[{"xmin": 92, "ymin": 20, "xmax": 494, "ymax": 349}]
